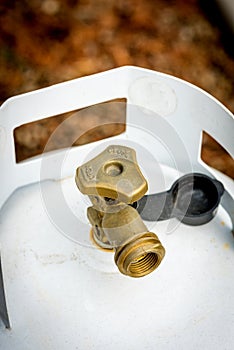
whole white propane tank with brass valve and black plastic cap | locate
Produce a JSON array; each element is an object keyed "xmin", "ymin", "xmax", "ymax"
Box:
[{"xmin": 0, "ymin": 66, "xmax": 234, "ymax": 350}]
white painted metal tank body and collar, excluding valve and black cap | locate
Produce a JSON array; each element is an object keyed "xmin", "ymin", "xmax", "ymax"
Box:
[{"xmin": 0, "ymin": 67, "xmax": 234, "ymax": 350}]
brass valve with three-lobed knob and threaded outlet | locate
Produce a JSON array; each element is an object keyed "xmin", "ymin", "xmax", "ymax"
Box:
[{"xmin": 76, "ymin": 145, "xmax": 165, "ymax": 277}]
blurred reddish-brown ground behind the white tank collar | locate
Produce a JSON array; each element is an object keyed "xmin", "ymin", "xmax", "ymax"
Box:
[{"xmin": 0, "ymin": 0, "xmax": 234, "ymax": 178}]
